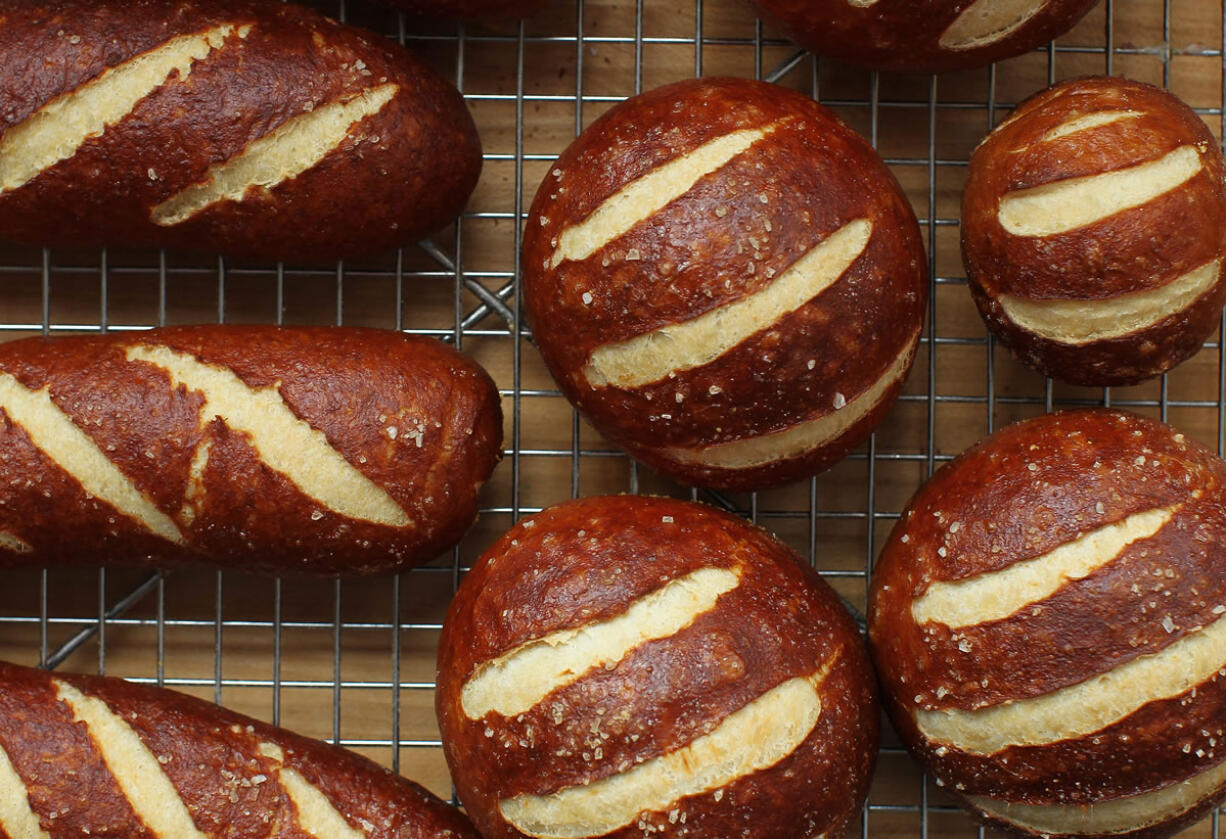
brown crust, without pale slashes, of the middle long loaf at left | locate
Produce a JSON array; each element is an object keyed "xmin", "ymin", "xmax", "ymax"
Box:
[{"xmin": 0, "ymin": 326, "xmax": 501, "ymax": 574}]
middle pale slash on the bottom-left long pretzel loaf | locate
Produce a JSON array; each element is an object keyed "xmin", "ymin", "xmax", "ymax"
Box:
[{"xmin": 54, "ymin": 680, "xmax": 206, "ymax": 839}]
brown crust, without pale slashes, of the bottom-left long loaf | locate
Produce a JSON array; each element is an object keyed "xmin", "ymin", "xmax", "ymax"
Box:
[{"xmin": 0, "ymin": 662, "xmax": 478, "ymax": 839}]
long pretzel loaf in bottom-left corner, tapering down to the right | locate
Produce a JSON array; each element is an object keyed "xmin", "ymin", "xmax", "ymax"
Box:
[{"xmin": 0, "ymin": 662, "xmax": 478, "ymax": 839}]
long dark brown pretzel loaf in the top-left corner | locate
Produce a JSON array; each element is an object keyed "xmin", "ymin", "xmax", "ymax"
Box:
[{"xmin": 0, "ymin": 0, "xmax": 481, "ymax": 260}]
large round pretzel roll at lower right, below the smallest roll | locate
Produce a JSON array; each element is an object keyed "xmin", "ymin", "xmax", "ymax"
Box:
[{"xmin": 869, "ymin": 410, "xmax": 1226, "ymax": 837}]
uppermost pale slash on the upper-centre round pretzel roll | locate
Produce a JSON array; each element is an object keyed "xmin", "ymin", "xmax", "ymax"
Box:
[{"xmin": 550, "ymin": 123, "xmax": 780, "ymax": 267}]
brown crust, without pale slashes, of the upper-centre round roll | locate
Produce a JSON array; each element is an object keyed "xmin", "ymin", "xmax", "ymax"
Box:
[{"xmin": 524, "ymin": 79, "xmax": 928, "ymax": 488}]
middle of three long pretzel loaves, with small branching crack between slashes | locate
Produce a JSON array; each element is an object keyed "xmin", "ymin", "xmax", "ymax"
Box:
[{"xmin": 0, "ymin": 326, "xmax": 501, "ymax": 574}]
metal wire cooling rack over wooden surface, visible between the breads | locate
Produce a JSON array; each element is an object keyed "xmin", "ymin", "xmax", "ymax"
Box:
[{"xmin": 0, "ymin": 0, "xmax": 1226, "ymax": 837}]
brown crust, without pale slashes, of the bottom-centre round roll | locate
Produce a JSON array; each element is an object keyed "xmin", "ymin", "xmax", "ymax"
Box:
[{"xmin": 436, "ymin": 497, "xmax": 878, "ymax": 839}]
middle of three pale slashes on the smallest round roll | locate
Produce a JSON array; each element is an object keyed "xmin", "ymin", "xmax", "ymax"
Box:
[{"xmin": 997, "ymin": 146, "xmax": 1203, "ymax": 236}]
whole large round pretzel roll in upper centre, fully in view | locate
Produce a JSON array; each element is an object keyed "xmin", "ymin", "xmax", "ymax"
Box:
[{"xmin": 522, "ymin": 79, "xmax": 927, "ymax": 488}]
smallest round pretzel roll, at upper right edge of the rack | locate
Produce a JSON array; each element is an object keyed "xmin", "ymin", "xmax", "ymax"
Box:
[{"xmin": 962, "ymin": 77, "xmax": 1226, "ymax": 385}]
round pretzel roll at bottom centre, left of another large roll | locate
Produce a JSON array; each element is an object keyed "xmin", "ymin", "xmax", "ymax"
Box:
[{"xmin": 436, "ymin": 496, "xmax": 878, "ymax": 839}]
